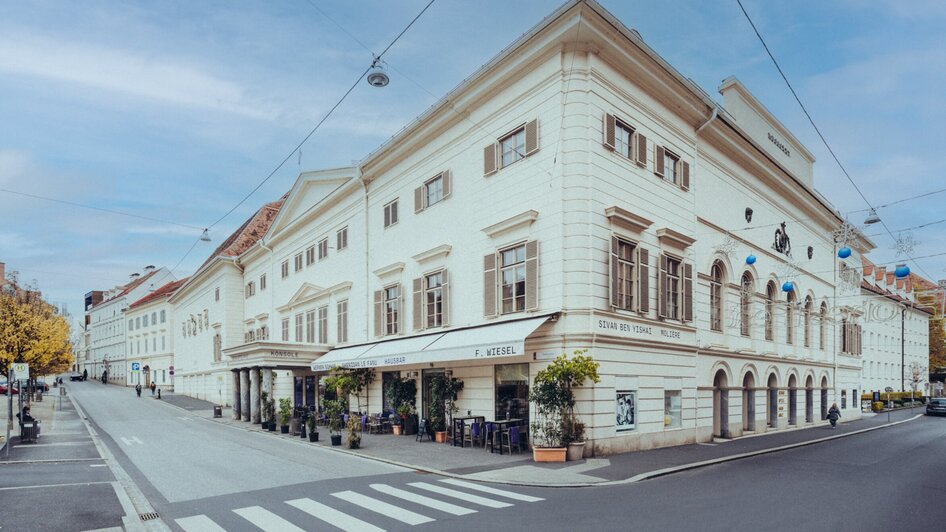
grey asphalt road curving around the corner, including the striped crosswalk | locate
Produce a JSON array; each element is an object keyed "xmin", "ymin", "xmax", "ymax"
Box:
[{"xmin": 73, "ymin": 383, "xmax": 946, "ymax": 532}]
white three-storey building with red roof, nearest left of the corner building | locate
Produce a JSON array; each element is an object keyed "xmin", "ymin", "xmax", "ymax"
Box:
[{"xmin": 125, "ymin": 277, "xmax": 187, "ymax": 390}]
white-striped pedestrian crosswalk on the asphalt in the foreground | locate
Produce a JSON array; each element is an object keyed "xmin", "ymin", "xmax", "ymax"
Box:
[{"xmin": 175, "ymin": 479, "xmax": 544, "ymax": 532}]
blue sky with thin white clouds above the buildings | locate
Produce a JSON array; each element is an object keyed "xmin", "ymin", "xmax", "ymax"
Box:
[{"xmin": 0, "ymin": 0, "xmax": 946, "ymax": 328}]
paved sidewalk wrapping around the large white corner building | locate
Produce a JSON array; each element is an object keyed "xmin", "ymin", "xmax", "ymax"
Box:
[{"xmin": 157, "ymin": 394, "xmax": 924, "ymax": 487}]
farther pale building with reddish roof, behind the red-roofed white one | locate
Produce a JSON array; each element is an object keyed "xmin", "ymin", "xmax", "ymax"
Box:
[{"xmin": 85, "ymin": 266, "xmax": 173, "ymax": 385}]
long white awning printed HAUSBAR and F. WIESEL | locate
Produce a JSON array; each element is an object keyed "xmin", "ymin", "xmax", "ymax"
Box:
[{"xmin": 312, "ymin": 316, "xmax": 549, "ymax": 371}]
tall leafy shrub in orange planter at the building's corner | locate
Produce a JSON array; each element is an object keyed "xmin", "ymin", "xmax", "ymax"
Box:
[{"xmin": 529, "ymin": 350, "xmax": 600, "ymax": 462}]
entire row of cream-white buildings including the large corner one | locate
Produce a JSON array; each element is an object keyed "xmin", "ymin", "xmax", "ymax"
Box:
[{"xmin": 74, "ymin": 1, "xmax": 930, "ymax": 454}]
